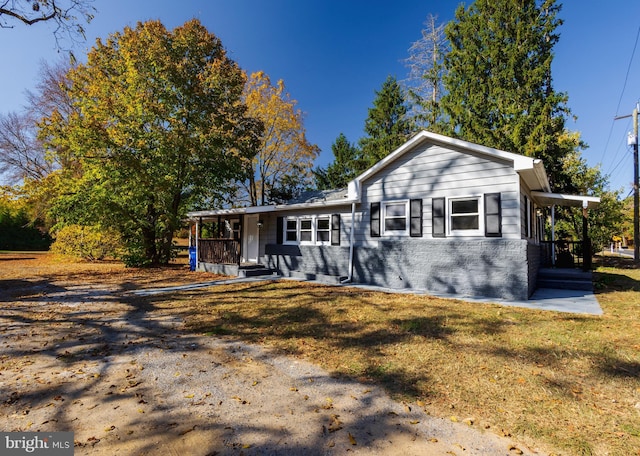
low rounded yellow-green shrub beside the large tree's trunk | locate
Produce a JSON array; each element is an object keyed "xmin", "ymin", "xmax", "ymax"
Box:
[{"xmin": 51, "ymin": 225, "xmax": 122, "ymax": 261}]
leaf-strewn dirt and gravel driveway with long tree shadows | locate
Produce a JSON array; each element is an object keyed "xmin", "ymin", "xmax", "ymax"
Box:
[{"xmin": 0, "ymin": 257, "xmax": 536, "ymax": 456}]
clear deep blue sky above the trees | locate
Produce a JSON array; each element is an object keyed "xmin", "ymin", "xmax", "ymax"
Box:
[{"xmin": 0, "ymin": 0, "xmax": 640, "ymax": 196}]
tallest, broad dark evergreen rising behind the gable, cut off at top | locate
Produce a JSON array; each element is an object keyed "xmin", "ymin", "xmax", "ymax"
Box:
[{"xmin": 441, "ymin": 0, "xmax": 569, "ymax": 190}]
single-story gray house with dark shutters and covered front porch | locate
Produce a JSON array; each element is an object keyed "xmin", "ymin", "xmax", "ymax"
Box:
[{"xmin": 188, "ymin": 131, "xmax": 599, "ymax": 300}]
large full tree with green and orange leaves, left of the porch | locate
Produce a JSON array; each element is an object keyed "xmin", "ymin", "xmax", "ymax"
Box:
[{"xmin": 42, "ymin": 20, "xmax": 261, "ymax": 264}]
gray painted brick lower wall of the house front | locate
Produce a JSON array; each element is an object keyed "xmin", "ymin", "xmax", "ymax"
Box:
[{"xmin": 265, "ymin": 239, "xmax": 538, "ymax": 300}]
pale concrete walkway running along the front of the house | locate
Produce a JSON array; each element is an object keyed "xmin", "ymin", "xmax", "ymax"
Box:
[{"xmin": 128, "ymin": 276, "xmax": 603, "ymax": 315}]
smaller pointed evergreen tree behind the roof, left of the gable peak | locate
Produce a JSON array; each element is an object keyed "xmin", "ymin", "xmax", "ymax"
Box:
[{"xmin": 360, "ymin": 76, "xmax": 414, "ymax": 169}]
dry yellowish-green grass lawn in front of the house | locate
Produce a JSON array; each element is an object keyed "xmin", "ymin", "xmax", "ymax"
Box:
[{"xmin": 0, "ymin": 251, "xmax": 640, "ymax": 455}]
